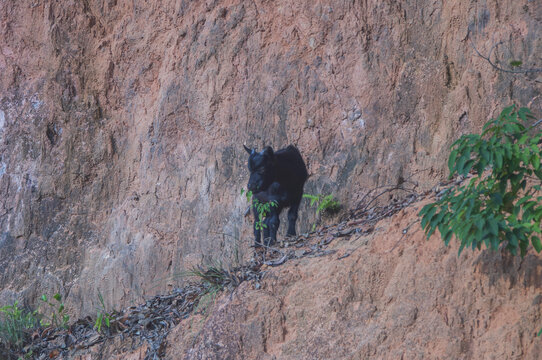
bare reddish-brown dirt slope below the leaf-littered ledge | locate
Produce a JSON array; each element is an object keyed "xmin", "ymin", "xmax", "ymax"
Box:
[{"xmin": 60, "ymin": 194, "xmax": 542, "ymax": 360}]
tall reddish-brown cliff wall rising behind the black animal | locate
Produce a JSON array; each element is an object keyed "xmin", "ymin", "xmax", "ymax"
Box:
[{"xmin": 0, "ymin": 0, "xmax": 542, "ymax": 320}]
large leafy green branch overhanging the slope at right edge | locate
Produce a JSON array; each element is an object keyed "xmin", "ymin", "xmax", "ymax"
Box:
[{"xmin": 419, "ymin": 106, "xmax": 542, "ymax": 256}]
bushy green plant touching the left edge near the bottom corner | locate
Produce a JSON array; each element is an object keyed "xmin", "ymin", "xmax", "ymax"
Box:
[{"xmin": 0, "ymin": 301, "xmax": 38, "ymax": 349}]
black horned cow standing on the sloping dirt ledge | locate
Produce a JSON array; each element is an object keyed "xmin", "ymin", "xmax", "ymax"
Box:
[{"xmin": 244, "ymin": 145, "xmax": 308, "ymax": 246}]
